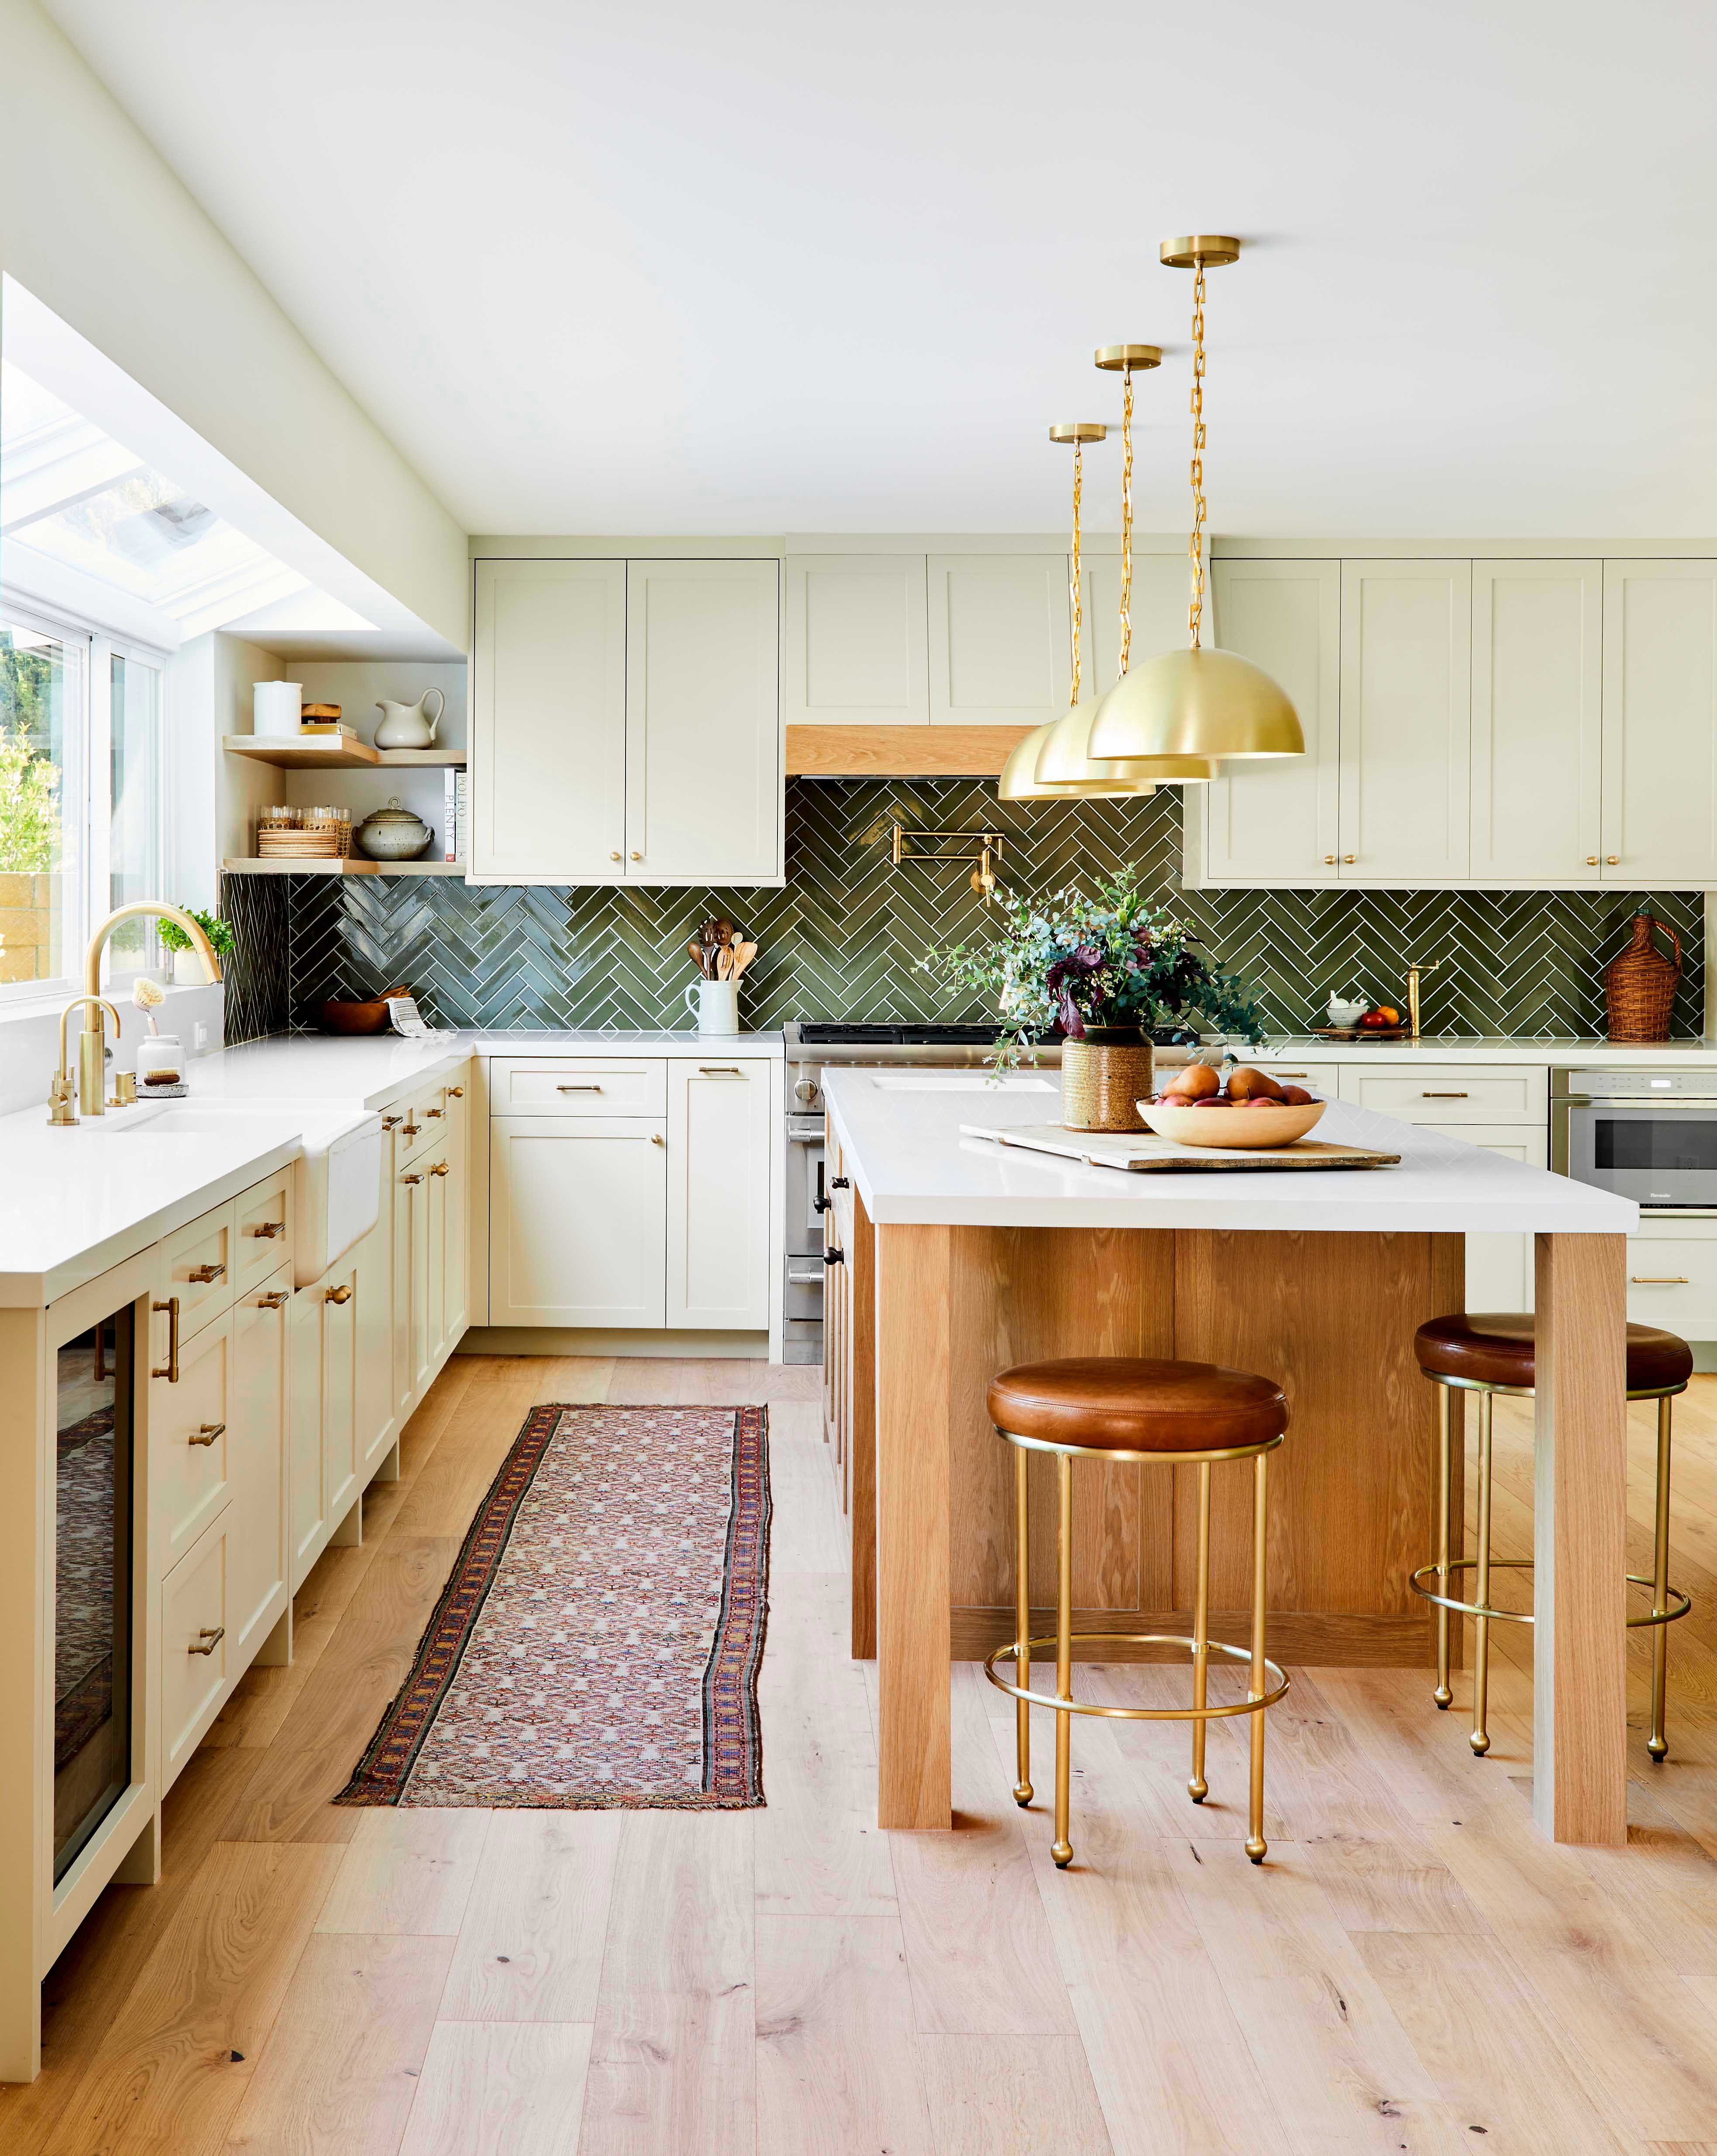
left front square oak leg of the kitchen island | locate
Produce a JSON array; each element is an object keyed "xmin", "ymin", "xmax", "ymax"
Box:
[{"xmin": 876, "ymin": 1227, "xmax": 953, "ymax": 1826}]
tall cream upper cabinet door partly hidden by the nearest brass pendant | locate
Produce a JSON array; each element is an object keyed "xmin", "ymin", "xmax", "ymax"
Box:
[{"xmin": 1182, "ymin": 560, "xmax": 1342, "ymax": 884}]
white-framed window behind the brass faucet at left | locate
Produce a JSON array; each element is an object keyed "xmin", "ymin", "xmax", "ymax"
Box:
[{"xmin": 0, "ymin": 606, "xmax": 164, "ymax": 1001}]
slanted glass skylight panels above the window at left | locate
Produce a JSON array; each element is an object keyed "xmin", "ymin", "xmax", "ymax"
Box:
[{"xmin": 0, "ymin": 360, "xmax": 315, "ymax": 638}]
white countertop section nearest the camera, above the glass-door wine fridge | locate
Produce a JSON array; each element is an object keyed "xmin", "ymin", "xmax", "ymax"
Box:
[{"xmin": 0, "ymin": 1108, "xmax": 306, "ymax": 1309}]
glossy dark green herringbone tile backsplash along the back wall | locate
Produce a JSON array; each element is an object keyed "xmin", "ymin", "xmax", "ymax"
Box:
[{"xmin": 224, "ymin": 778, "xmax": 1704, "ymax": 1039}]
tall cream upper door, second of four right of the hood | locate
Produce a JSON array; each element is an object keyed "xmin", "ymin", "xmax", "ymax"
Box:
[{"xmin": 1335, "ymin": 560, "xmax": 1473, "ymax": 884}]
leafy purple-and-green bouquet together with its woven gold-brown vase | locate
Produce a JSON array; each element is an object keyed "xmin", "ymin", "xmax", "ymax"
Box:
[{"xmin": 919, "ymin": 869, "xmax": 1264, "ymax": 1130}]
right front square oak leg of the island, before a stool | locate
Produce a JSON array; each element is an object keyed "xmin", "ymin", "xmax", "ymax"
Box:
[{"xmin": 1531, "ymin": 1235, "xmax": 1626, "ymax": 1843}]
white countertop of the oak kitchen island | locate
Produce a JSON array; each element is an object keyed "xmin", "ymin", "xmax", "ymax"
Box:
[{"xmin": 824, "ymin": 1069, "xmax": 1639, "ymax": 1235}]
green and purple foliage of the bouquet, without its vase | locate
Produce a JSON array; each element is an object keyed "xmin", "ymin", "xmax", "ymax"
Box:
[{"xmin": 919, "ymin": 869, "xmax": 1264, "ymax": 1072}]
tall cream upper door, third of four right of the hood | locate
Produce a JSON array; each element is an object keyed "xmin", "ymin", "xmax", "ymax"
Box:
[{"xmin": 1471, "ymin": 560, "xmax": 1603, "ymax": 884}]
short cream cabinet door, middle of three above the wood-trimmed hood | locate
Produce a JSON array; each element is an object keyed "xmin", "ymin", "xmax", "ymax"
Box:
[{"xmin": 928, "ymin": 554, "xmax": 1072, "ymax": 726}]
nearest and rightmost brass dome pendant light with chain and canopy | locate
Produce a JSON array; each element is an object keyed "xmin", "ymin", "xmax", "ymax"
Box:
[{"xmin": 1087, "ymin": 233, "xmax": 1305, "ymax": 770}]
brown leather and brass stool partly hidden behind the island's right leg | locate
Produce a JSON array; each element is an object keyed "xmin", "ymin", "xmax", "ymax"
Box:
[{"xmin": 1413, "ymin": 1311, "xmax": 1693, "ymax": 1759}]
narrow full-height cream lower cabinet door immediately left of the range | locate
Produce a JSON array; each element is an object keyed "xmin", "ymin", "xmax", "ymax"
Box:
[{"xmin": 667, "ymin": 1054, "xmax": 774, "ymax": 1330}]
